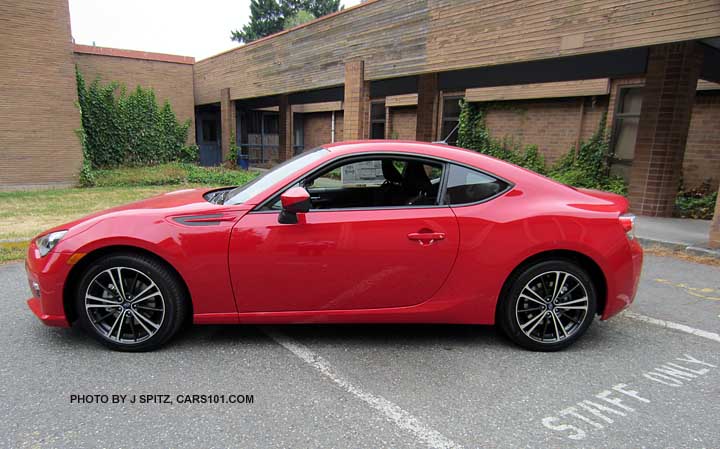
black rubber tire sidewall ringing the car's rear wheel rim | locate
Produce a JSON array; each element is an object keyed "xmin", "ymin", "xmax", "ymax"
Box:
[{"xmin": 500, "ymin": 260, "xmax": 597, "ymax": 351}]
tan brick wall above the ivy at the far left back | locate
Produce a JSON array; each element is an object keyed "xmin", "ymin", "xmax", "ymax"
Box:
[{"xmin": 75, "ymin": 46, "xmax": 195, "ymax": 143}]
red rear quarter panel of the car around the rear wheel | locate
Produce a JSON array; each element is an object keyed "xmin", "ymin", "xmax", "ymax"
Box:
[{"xmin": 438, "ymin": 186, "xmax": 634, "ymax": 324}]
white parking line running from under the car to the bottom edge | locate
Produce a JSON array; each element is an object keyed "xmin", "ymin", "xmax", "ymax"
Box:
[{"xmin": 264, "ymin": 329, "xmax": 461, "ymax": 449}]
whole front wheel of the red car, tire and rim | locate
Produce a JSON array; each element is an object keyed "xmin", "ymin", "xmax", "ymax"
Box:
[{"xmin": 75, "ymin": 253, "xmax": 190, "ymax": 352}]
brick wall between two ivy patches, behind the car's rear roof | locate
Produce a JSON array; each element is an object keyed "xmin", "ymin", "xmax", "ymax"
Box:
[{"xmin": 486, "ymin": 97, "xmax": 608, "ymax": 164}]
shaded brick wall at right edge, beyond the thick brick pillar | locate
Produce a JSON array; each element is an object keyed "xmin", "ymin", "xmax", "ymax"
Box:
[{"xmin": 683, "ymin": 91, "xmax": 720, "ymax": 190}]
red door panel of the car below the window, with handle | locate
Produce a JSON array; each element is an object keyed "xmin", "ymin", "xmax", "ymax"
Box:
[{"xmin": 229, "ymin": 156, "xmax": 459, "ymax": 313}]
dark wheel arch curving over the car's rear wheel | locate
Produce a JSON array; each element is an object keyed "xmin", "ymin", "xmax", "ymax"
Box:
[{"xmin": 495, "ymin": 249, "xmax": 608, "ymax": 322}]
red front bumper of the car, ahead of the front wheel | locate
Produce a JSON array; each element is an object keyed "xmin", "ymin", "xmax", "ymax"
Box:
[{"xmin": 25, "ymin": 242, "xmax": 72, "ymax": 327}]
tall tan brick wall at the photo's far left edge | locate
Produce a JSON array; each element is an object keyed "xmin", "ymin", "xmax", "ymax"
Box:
[{"xmin": 0, "ymin": 0, "xmax": 82, "ymax": 188}]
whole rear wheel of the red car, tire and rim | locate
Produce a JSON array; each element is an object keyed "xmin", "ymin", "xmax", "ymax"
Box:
[{"xmin": 498, "ymin": 259, "xmax": 597, "ymax": 351}]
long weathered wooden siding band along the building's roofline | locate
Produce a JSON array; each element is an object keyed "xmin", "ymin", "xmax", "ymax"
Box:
[{"xmin": 195, "ymin": 0, "xmax": 720, "ymax": 104}]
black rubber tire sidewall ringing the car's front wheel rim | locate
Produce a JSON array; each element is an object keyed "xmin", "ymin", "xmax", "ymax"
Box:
[{"xmin": 75, "ymin": 254, "xmax": 183, "ymax": 351}]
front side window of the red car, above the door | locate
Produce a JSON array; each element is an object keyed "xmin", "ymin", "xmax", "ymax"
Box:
[{"xmin": 268, "ymin": 157, "xmax": 444, "ymax": 210}]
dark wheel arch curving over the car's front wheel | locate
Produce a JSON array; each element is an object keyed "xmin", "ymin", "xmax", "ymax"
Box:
[{"xmin": 63, "ymin": 245, "xmax": 193, "ymax": 324}]
